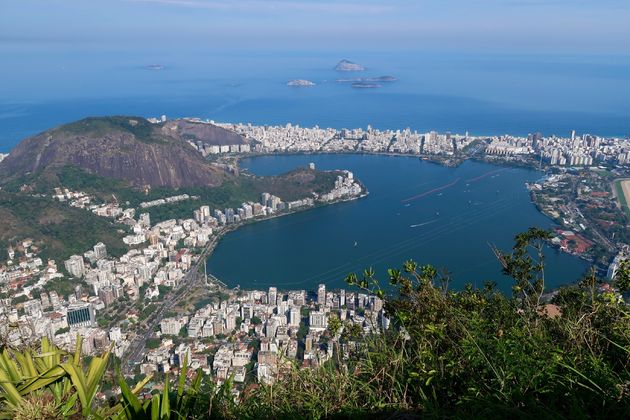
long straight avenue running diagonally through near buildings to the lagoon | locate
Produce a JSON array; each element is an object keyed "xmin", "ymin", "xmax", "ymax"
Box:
[{"xmin": 122, "ymin": 233, "xmax": 232, "ymax": 374}]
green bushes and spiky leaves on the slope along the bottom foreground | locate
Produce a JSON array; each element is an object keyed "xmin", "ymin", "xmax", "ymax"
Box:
[{"xmin": 0, "ymin": 229, "xmax": 630, "ymax": 419}]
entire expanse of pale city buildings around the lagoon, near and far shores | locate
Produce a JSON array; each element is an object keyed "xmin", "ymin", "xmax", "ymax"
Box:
[{"xmin": 0, "ymin": 117, "xmax": 630, "ymax": 400}]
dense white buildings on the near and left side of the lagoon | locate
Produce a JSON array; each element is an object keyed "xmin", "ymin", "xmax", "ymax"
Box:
[{"xmin": 0, "ymin": 161, "xmax": 368, "ymax": 390}]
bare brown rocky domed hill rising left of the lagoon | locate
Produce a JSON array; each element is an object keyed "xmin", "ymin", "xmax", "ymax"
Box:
[{"xmin": 0, "ymin": 117, "xmax": 243, "ymax": 188}]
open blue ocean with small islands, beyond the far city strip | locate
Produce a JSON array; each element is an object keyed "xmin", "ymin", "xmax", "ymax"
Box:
[{"xmin": 0, "ymin": 48, "xmax": 630, "ymax": 153}]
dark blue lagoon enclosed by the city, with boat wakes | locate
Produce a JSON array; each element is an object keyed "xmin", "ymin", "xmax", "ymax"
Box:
[{"xmin": 208, "ymin": 155, "xmax": 587, "ymax": 292}]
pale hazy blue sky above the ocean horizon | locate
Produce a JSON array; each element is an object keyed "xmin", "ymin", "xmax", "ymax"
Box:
[{"xmin": 0, "ymin": 0, "xmax": 630, "ymax": 55}]
